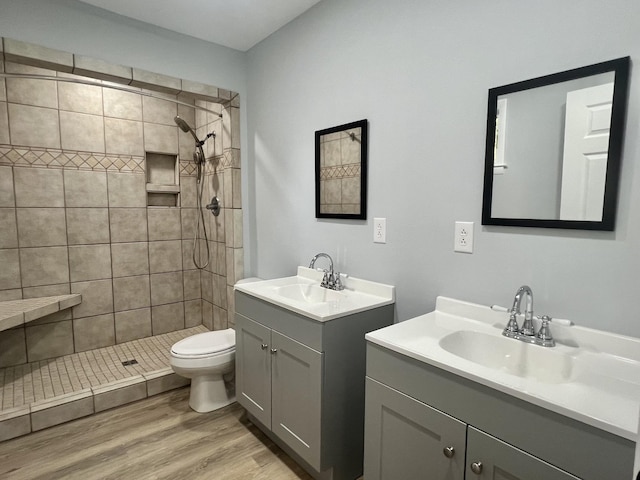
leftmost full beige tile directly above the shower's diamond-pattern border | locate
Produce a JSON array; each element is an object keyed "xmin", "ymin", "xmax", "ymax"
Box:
[{"xmin": 9, "ymin": 103, "xmax": 60, "ymax": 148}]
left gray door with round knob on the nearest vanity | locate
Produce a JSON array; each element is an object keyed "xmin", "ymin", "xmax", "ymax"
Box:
[{"xmin": 364, "ymin": 377, "xmax": 467, "ymax": 480}]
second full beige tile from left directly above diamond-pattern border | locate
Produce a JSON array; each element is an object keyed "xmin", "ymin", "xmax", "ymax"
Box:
[{"xmin": 60, "ymin": 110, "xmax": 106, "ymax": 153}]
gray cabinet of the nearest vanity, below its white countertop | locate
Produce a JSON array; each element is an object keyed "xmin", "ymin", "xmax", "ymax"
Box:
[{"xmin": 364, "ymin": 343, "xmax": 633, "ymax": 480}]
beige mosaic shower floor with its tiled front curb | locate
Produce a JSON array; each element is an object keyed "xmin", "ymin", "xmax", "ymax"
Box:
[{"xmin": 0, "ymin": 325, "xmax": 208, "ymax": 441}]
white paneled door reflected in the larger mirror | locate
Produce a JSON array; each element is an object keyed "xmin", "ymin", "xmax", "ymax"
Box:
[{"xmin": 560, "ymin": 83, "xmax": 613, "ymax": 221}]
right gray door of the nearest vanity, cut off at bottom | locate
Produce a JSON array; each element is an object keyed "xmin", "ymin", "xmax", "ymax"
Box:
[{"xmin": 466, "ymin": 425, "xmax": 579, "ymax": 480}]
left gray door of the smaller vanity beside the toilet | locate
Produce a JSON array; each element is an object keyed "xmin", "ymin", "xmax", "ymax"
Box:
[{"xmin": 236, "ymin": 314, "xmax": 273, "ymax": 428}]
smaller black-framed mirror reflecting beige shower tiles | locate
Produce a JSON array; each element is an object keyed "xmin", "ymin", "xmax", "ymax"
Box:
[{"xmin": 316, "ymin": 120, "xmax": 367, "ymax": 220}]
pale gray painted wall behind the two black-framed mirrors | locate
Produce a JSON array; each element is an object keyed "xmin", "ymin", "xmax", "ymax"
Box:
[{"xmin": 246, "ymin": 0, "xmax": 640, "ymax": 336}]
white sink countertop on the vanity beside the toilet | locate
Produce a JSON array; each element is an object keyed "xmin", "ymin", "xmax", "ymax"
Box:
[{"xmin": 234, "ymin": 267, "xmax": 395, "ymax": 322}]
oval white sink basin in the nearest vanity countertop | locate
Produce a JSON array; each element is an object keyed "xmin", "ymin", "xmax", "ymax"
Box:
[{"xmin": 439, "ymin": 330, "xmax": 574, "ymax": 383}]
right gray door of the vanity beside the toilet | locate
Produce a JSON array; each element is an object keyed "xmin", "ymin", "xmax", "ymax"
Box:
[{"xmin": 271, "ymin": 330, "xmax": 323, "ymax": 470}]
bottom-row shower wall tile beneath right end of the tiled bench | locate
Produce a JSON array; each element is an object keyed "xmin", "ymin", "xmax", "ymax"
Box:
[{"xmin": 25, "ymin": 320, "xmax": 73, "ymax": 362}]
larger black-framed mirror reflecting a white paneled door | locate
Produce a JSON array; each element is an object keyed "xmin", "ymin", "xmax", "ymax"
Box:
[{"xmin": 482, "ymin": 57, "xmax": 630, "ymax": 231}]
